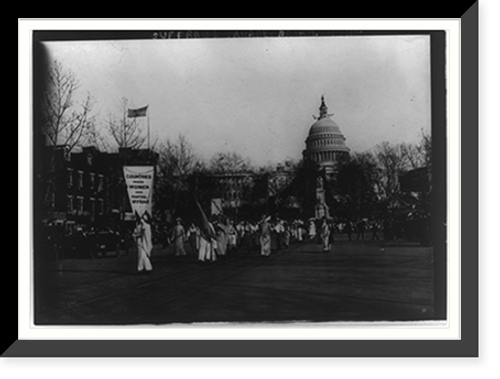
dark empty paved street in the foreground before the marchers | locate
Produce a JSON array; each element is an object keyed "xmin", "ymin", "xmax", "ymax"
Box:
[{"xmin": 35, "ymin": 236, "xmax": 433, "ymax": 325}]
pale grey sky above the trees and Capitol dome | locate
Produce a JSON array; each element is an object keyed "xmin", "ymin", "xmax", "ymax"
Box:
[{"xmin": 45, "ymin": 35, "xmax": 431, "ymax": 165}]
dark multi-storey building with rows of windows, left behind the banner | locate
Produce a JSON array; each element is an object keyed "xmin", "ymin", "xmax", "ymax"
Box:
[{"xmin": 40, "ymin": 146, "xmax": 158, "ymax": 229}]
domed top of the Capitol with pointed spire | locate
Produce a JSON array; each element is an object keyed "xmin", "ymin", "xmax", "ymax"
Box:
[{"xmin": 302, "ymin": 96, "xmax": 349, "ymax": 179}]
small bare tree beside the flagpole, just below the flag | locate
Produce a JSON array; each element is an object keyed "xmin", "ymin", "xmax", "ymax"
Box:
[{"xmin": 106, "ymin": 98, "xmax": 146, "ymax": 149}]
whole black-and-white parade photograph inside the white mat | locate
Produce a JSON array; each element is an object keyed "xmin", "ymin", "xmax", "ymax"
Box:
[{"xmin": 30, "ymin": 30, "xmax": 447, "ymax": 327}]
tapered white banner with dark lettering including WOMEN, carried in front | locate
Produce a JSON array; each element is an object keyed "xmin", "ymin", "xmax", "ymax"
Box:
[{"xmin": 123, "ymin": 166, "xmax": 154, "ymax": 217}]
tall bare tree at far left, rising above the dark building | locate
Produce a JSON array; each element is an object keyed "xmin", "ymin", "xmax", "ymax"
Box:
[{"xmin": 42, "ymin": 61, "xmax": 95, "ymax": 151}]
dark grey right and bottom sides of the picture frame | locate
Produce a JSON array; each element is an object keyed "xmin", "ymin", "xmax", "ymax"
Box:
[{"xmin": 11, "ymin": 8, "xmax": 479, "ymax": 358}]
